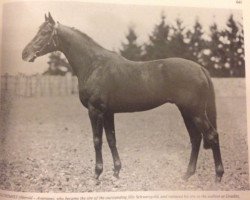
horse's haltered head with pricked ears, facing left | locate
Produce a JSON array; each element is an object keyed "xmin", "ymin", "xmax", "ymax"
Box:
[{"xmin": 22, "ymin": 13, "xmax": 57, "ymax": 62}]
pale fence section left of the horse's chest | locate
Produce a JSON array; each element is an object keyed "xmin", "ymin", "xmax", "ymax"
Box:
[{"xmin": 1, "ymin": 74, "xmax": 78, "ymax": 97}]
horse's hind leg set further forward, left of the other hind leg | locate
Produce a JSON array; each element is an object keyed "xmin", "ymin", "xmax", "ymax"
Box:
[{"xmin": 180, "ymin": 109, "xmax": 201, "ymax": 180}]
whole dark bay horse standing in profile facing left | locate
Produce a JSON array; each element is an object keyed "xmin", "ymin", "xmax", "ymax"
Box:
[{"xmin": 22, "ymin": 13, "xmax": 224, "ymax": 181}]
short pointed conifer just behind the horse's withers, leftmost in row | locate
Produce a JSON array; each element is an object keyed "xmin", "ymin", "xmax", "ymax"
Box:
[{"xmin": 120, "ymin": 26, "xmax": 142, "ymax": 61}]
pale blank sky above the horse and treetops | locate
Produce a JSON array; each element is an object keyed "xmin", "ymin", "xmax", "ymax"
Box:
[{"xmin": 2, "ymin": 1, "xmax": 242, "ymax": 74}]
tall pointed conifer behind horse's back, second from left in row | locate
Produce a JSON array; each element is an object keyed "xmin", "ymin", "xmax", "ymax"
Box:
[{"xmin": 143, "ymin": 14, "xmax": 171, "ymax": 60}]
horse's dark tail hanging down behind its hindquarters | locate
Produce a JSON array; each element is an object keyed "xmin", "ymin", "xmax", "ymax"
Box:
[{"xmin": 202, "ymin": 67, "xmax": 217, "ymax": 129}]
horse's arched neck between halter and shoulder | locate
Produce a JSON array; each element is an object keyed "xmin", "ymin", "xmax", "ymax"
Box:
[{"xmin": 58, "ymin": 25, "xmax": 107, "ymax": 79}]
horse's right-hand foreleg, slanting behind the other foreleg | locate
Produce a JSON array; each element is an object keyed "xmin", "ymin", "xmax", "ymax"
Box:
[{"xmin": 104, "ymin": 113, "xmax": 121, "ymax": 178}]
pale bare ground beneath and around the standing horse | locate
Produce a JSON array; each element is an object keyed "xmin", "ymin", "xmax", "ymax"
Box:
[{"xmin": 0, "ymin": 79, "xmax": 249, "ymax": 192}]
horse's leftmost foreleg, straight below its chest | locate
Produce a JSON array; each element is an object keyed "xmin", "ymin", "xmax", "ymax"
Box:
[{"xmin": 88, "ymin": 105, "xmax": 103, "ymax": 179}]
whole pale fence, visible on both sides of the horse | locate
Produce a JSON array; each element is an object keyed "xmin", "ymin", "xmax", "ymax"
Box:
[{"xmin": 1, "ymin": 74, "xmax": 246, "ymax": 97}]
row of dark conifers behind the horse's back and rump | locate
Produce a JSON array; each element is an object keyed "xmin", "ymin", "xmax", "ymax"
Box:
[{"xmin": 120, "ymin": 15, "xmax": 245, "ymax": 77}]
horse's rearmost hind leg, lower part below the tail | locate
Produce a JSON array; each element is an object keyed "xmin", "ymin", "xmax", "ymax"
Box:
[{"xmin": 193, "ymin": 113, "xmax": 224, "ymax": 182}]
